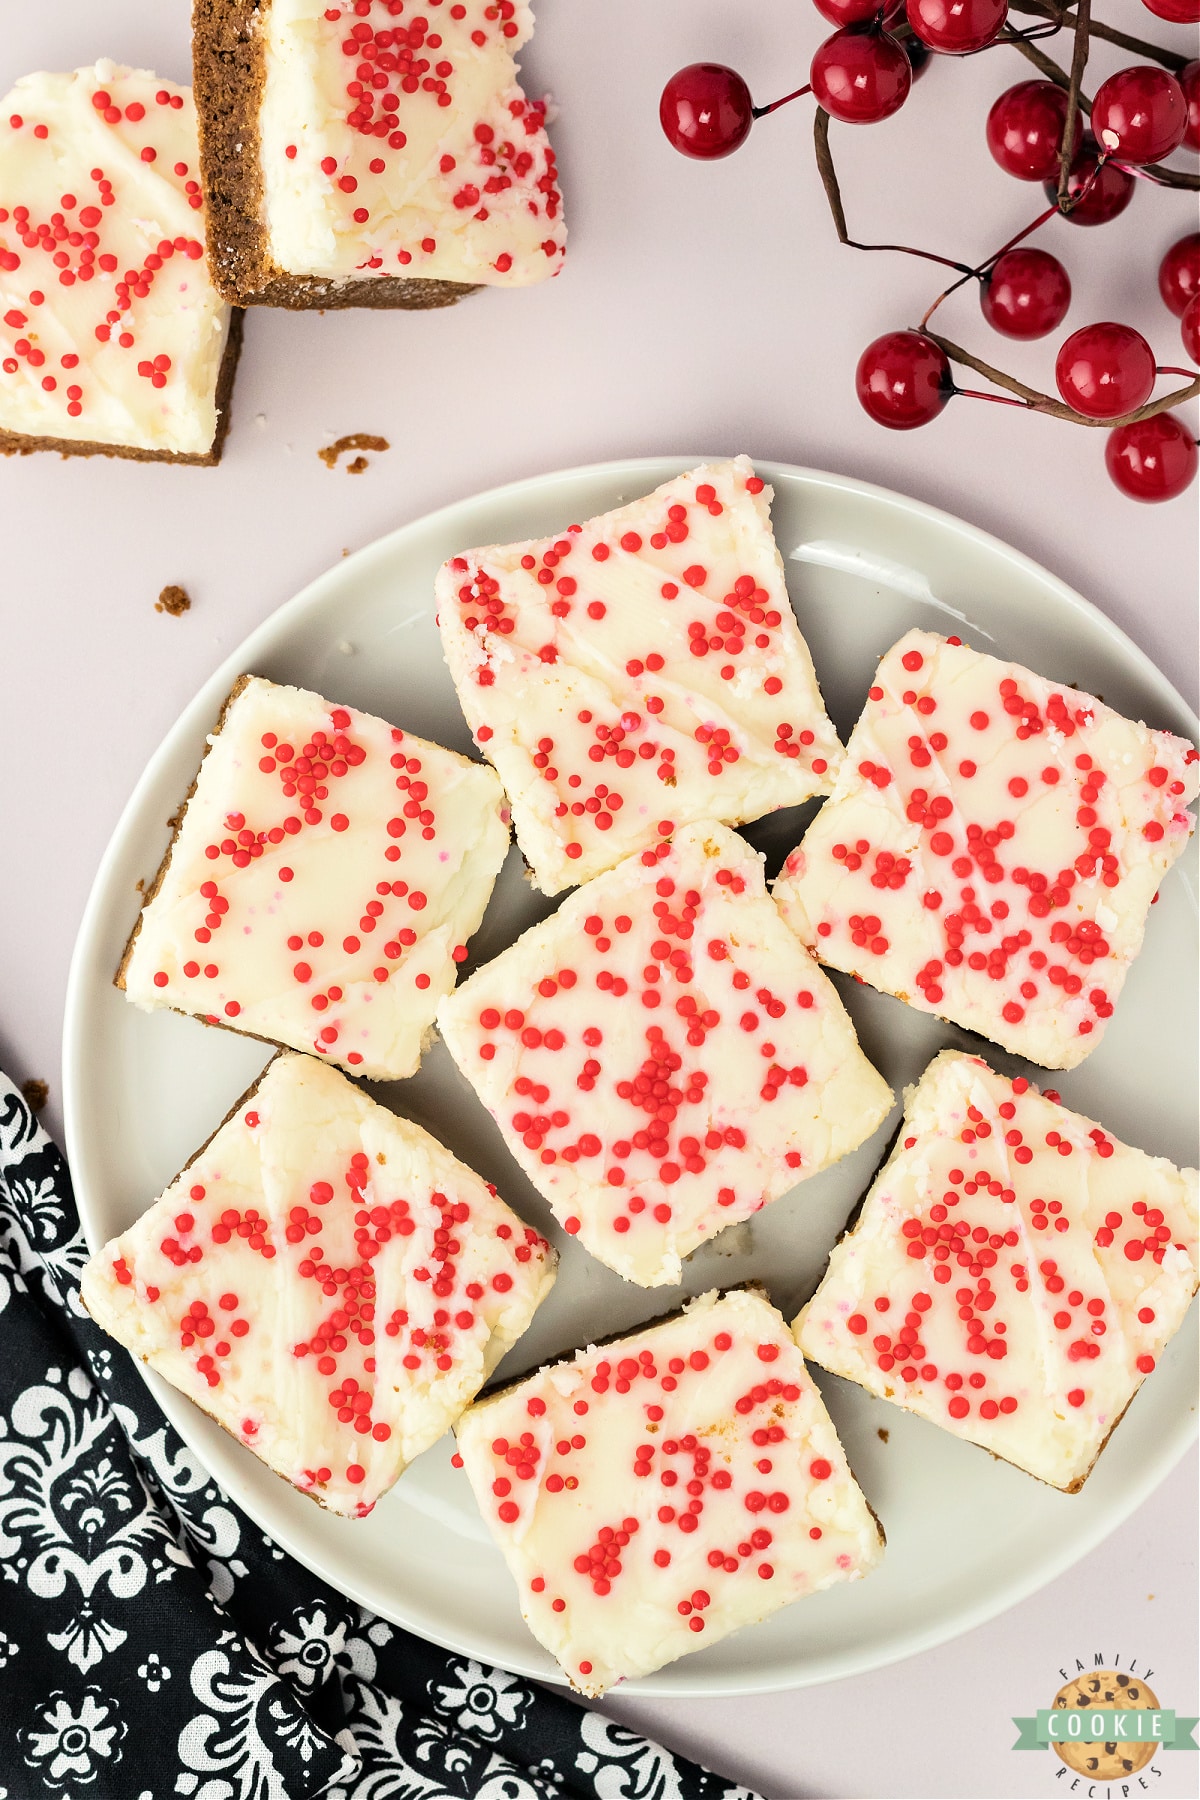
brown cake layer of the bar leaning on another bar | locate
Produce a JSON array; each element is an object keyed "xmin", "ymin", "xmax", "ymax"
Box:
[{"xmin": 193, "ymin": 0, "xmax": 475, "ymax": 311}]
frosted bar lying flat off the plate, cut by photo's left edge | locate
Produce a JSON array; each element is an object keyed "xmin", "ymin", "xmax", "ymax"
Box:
[{"xmin": 0, "ymin": 61, "xmax": 241, "ymax": 463}]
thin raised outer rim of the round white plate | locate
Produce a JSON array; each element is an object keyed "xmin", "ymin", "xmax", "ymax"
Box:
[{"xmin": 61, "ymin": 454, "xmax": 1200, "ymax": 1699}]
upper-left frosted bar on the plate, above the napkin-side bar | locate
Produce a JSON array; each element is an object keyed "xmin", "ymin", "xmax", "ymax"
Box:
[{"xmin": 117, "ymin": 675, "xmax": 509, "ymax": 1080}]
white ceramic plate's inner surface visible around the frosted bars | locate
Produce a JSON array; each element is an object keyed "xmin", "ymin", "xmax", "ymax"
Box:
[{"xmin": 63, "ymin": 457, "xmax": 1198, "ymax": 1696}]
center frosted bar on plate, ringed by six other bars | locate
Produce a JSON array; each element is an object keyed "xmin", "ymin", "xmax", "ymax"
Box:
[{"xmin": 437, "ymin": 824, "xmax": 892, "ymax": 1287}]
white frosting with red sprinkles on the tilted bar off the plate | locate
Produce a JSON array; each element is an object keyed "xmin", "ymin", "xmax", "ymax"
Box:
[{"xmin": 259, "ymin": 0, "xmax": 567, "ymax": 288}]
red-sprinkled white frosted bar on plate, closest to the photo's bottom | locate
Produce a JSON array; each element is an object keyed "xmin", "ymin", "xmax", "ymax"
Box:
[{"xmin": 449, "ymin": 1289, "xmax": 883, "ymax": 1694}]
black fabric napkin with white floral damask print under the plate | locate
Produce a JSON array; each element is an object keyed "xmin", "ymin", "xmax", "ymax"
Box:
[{"xmin": 0, "ymin": 1076, "xmax": 756, "ymax": 1800}]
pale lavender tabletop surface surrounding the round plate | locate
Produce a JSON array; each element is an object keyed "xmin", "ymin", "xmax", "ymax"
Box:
[{"xmin": 0, "ymin": 0, "xmax": 1198, "ymax": 1800}]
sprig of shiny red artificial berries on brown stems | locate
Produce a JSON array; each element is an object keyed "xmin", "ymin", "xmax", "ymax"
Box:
[{"xmin": 660, "ymin": 0, "xmax": 1200, "ymax": 500}]
